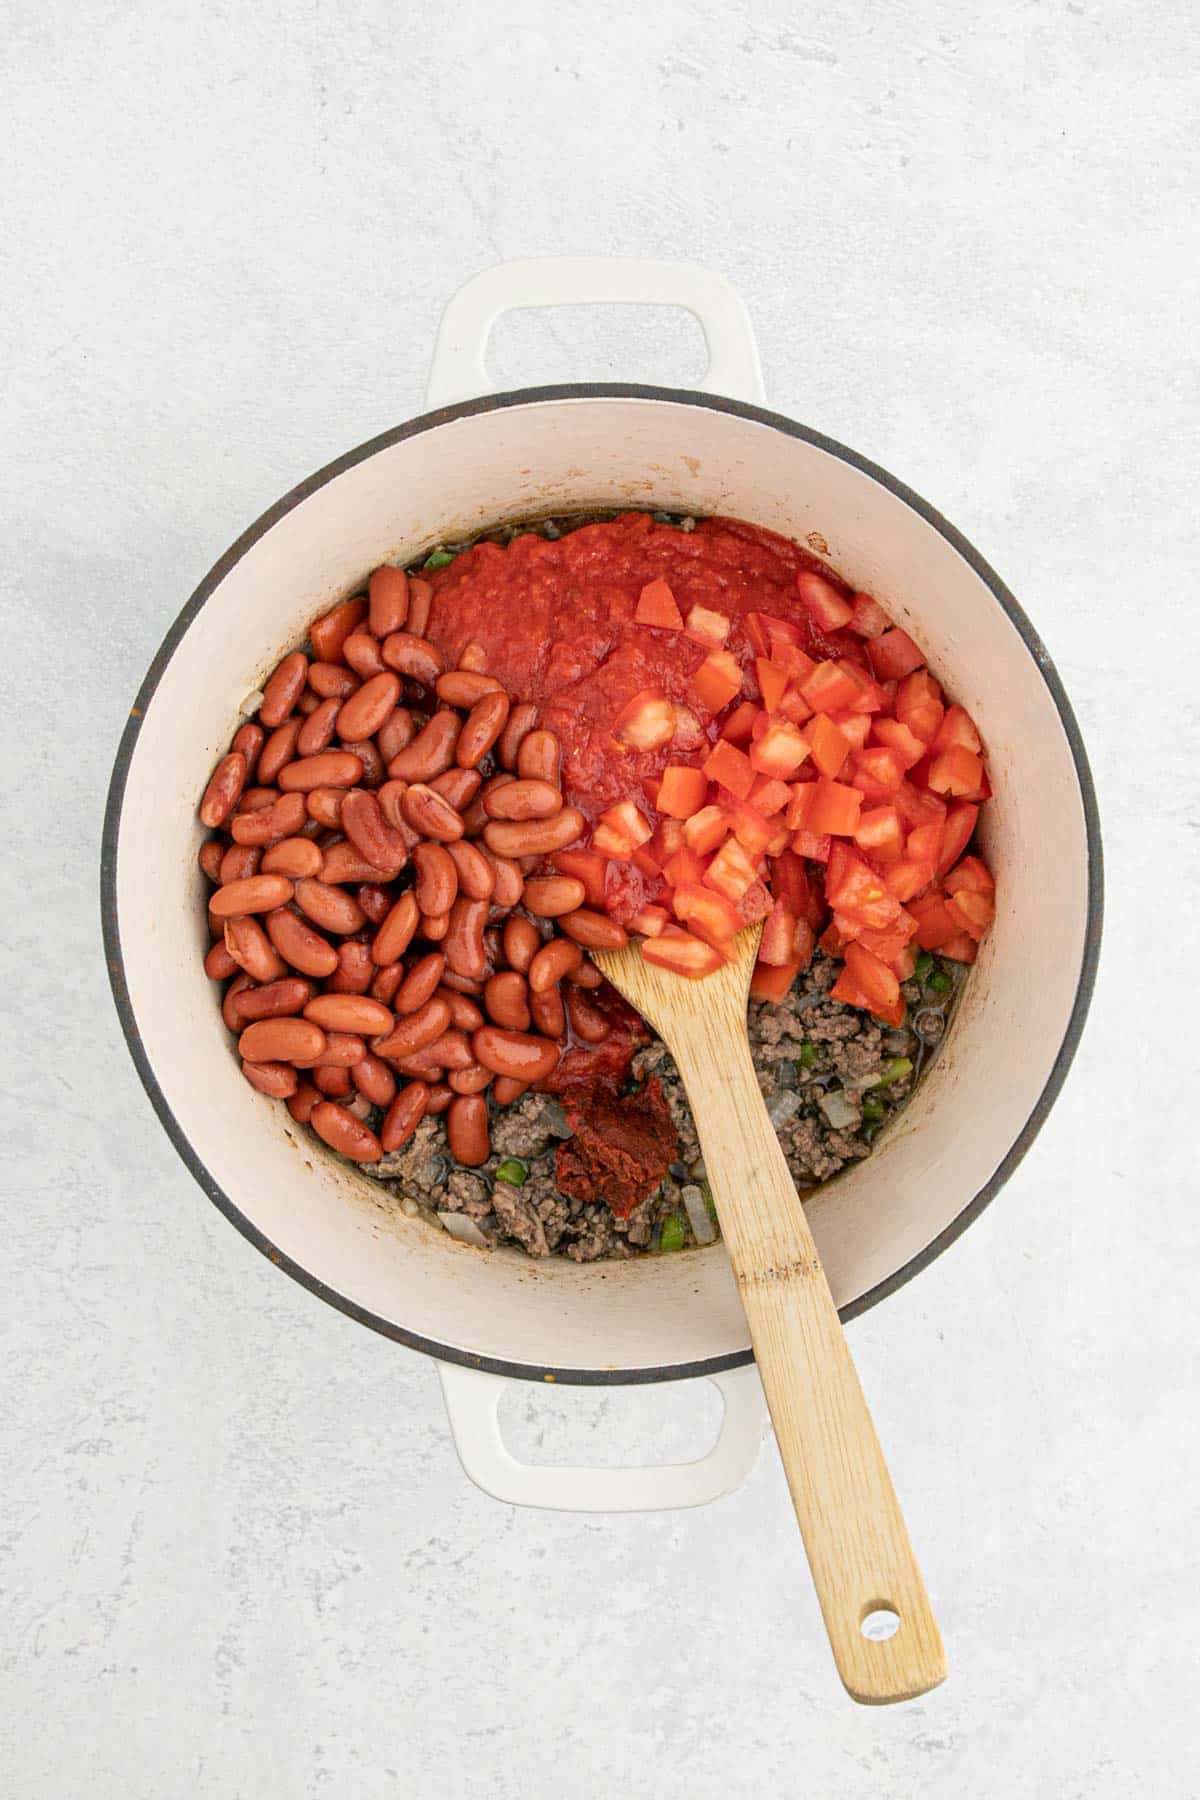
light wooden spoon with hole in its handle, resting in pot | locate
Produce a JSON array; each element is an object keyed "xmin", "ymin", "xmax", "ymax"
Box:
[{"xmin": 592, "ymin": 925, "xmax": 946, "ymax": 1705}]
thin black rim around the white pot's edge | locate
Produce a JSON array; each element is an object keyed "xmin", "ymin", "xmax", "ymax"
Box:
[{"xmin": 101, "ymin": 382, "xmax": 1105, "ymax": 1386}]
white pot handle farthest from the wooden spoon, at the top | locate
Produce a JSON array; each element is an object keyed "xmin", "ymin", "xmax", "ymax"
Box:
[{"xmin": 425, "ymin": 256, "xmax": 765, "ymax": 410}]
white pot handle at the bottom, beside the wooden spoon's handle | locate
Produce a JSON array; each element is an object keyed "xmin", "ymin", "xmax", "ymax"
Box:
[{"xmin": 437, "ymin": 1363, "xmax": 766, "ymax": 1512}]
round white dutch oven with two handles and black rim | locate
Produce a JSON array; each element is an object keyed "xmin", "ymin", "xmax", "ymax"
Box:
[{"xmin": 103, "ymin": 259, "xmax": 1101, "ymax": 1508}]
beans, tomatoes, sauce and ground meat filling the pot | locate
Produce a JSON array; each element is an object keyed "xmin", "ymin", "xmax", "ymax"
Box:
[{"xmin": 200, "ymin": 513, "xmax": 993, "ymax": 1260}]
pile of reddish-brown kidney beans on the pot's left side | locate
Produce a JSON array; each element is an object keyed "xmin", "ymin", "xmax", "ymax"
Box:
[{"xmin": 200, "ymin": 567, "xmax": 626, "ymax": 1166}]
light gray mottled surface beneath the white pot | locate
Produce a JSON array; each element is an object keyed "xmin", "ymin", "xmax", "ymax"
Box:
[{"xmin": 0, "ymin": 0, "xmax": 1200, "ymax": 1800}]
